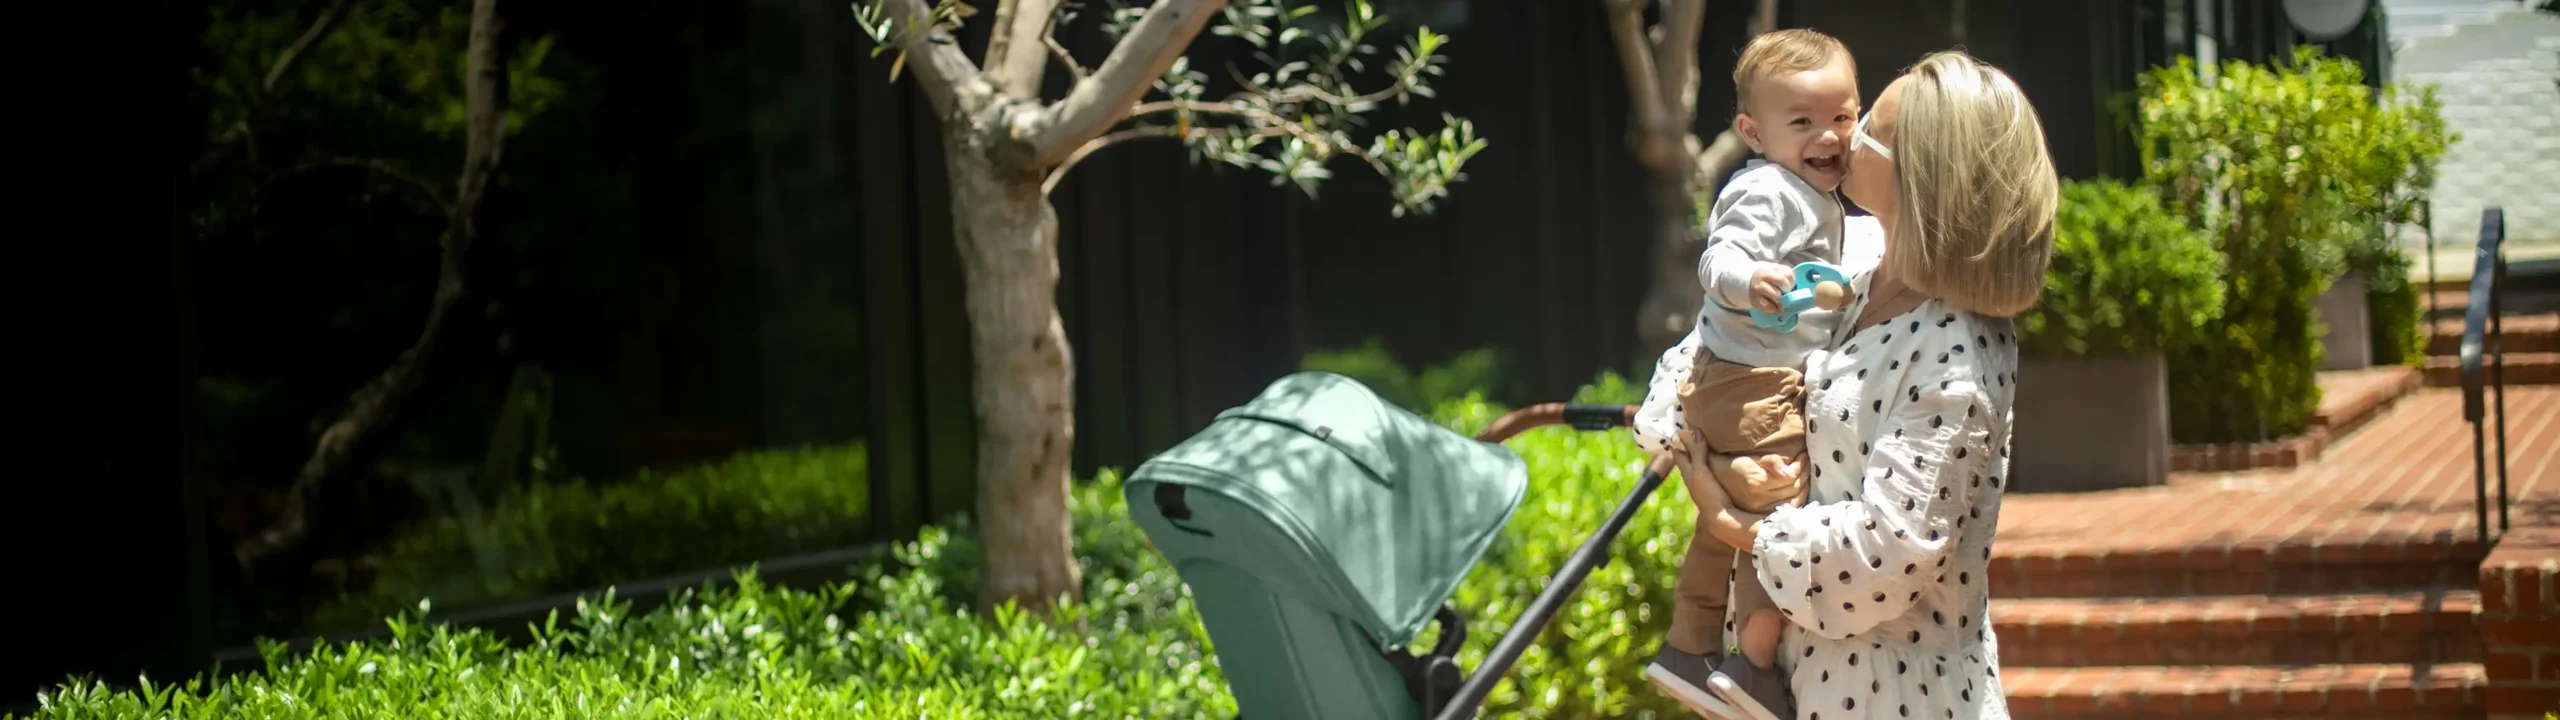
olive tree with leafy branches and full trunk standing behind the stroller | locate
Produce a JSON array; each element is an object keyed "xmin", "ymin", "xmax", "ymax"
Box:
[{"xmin": 855, "ymin": 0, "xmax": 1485, "ymax": 612}]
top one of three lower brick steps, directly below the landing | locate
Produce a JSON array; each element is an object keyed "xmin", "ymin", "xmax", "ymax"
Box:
[{"xmin": 1992, "ymin": 533, "xmax": 2486, "ymax": 597}]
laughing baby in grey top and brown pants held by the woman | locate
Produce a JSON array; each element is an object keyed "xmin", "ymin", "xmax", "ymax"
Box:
[{"xmin": 1636, "ymin": 28, "xmax": 1859, "ymax": 717}]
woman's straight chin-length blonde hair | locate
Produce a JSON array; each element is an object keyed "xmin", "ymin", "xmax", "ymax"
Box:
[{"xmin": 1884, "ymin": 51, "xmax": 2061, "ymax": 318}]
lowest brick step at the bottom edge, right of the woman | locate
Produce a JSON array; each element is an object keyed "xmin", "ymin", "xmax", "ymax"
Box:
[{"xmin": 1999, "ymin": 656, "xmax": 2488, "ymax": 720}]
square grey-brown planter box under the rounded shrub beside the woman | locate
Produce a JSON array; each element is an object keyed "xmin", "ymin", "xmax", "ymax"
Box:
[{"xmin": 2010, "ymin": 354, "xmax": 2168, "ymax": 492}]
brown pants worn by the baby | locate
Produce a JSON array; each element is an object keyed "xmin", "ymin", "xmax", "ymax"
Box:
[{"xmin": 1669, "ymin": 348, "xmax": 1805, "ymax": 653}]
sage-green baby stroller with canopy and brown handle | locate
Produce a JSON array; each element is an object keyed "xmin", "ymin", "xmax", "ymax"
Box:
[{"xmin": 1124, "ymin": 372, "xmax": 1669, "ymax": 720}]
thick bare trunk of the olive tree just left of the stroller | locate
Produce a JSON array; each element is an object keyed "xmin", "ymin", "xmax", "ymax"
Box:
[{"xmin": 942, "ymin": 123, "xmax": 1083, "ymax": 615}]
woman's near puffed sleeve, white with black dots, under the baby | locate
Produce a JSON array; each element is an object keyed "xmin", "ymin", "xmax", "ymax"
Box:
[{"xmin": 1751, "ymin": 341, "xmax": 1994, "ymax": 638}]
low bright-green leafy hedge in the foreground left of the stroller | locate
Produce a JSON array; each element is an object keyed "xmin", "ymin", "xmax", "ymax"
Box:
[{"xmin": 33, "ymin": 477, "xmax": 1234, "ymax": 720}]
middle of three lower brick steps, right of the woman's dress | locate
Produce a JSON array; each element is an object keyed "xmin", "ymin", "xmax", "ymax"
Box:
[{"xmin": 1992, "ymin": 589, "xmax": 2481, "ymax": 666}]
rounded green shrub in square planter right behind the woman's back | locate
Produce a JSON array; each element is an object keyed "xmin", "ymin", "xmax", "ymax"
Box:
[{"xmin": 2010, "ymin": 179, "xmax": 2222, "ymax": 492}]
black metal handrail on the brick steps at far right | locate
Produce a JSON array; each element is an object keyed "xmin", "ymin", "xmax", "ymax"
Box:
[{"xmin": 2463, "ymin": 208, "xmax": 2506, "ymax": 548}]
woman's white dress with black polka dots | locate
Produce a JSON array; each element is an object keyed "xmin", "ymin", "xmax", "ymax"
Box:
[{"xmin": 1728, "ymin": 277, "xmax": 2017, "ymax": 720}]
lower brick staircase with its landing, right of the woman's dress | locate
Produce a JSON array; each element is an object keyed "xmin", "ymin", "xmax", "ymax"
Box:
[{"xmin": 1992, "ymin": 379, "xmax": 2560, "ymax": 720}]
